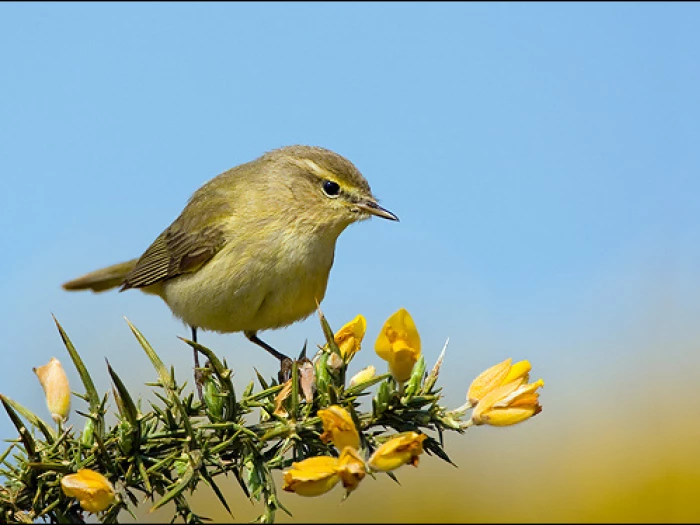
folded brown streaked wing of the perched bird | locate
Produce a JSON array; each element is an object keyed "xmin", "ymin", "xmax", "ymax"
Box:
[{"xmin": 120, "ymin": 222, "xmax": 224, "ymax": 291}]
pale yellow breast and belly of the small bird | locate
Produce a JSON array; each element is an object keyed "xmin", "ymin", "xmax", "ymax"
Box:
[{"xmin": 162, "ymin": 224, "xmax": 337, "ymax": 332}]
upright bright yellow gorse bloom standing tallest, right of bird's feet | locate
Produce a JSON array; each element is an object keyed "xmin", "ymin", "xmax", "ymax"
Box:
[{"xmin": 374, "ymin": 308, "xmax": 420, "ymax": 383}]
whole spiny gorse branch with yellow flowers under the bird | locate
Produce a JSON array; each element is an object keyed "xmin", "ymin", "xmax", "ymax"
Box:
[{"xmin": 0, "ymin": 309, "xmax": 543, "ymax": 523}]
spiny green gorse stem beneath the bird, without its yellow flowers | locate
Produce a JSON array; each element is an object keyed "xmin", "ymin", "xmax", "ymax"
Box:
[{"xmin": 0, "ymin": 318, "xmax": 540, "ymax": 523}]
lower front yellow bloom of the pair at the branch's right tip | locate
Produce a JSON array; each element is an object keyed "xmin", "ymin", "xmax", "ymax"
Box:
[{"xmin": 471, "ymin": 379, "xmax": 544, "ymax": 427}]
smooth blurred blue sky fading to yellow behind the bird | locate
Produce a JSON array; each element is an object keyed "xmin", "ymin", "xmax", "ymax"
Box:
[{"xmin": 0, "ymin": 2, "xmax": 700, "ymax": 522}]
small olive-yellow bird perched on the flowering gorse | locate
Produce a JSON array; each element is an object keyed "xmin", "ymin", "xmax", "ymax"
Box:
[{"xmin": 63, "ymin": 146, "xmax": 398, "ymax": 378}]
